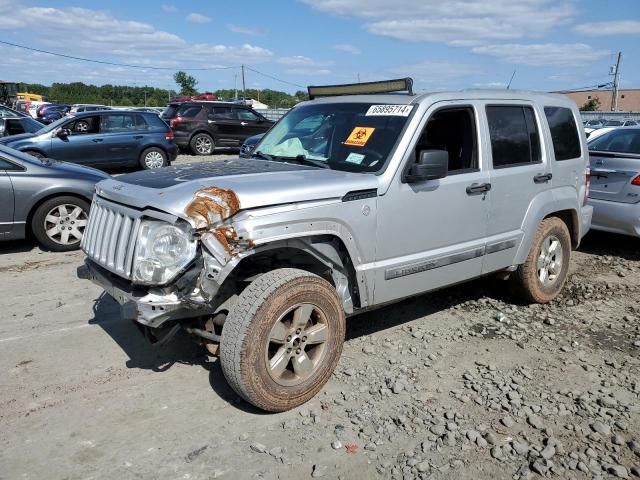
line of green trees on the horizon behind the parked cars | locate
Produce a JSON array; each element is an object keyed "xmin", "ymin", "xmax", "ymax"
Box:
[{"xmin": 18, "ymin": 82, "xmax": 307, "ymax": 108}]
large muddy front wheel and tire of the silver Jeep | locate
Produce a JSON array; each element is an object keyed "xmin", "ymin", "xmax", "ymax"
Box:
[{"xmin": 220, "ymin": 268, "xmax": 345, "ymax": 412}]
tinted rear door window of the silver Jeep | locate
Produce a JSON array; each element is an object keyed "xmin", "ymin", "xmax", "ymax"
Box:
[{"xmin": 487, "ymin": 105, "xmax": 541, "ymax": 168}]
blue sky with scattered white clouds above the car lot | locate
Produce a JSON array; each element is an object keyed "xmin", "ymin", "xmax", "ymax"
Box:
[{"xmin": 0, "ymin": 0, "xmax": 640, "ymax": 92}]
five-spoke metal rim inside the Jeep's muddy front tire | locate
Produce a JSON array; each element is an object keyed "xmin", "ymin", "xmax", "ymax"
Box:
[{"xmin": 265, "ymin": 303, "xmax": 329, "ymax": 387}]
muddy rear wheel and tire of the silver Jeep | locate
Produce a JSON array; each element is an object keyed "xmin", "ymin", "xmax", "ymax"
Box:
[{"xmin": 510, "ymin": 217, "xmax": 571, "ymax": 303}]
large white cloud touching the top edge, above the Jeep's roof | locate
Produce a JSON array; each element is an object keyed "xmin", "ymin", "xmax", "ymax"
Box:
[{"xmin": 303, "ymin": 0, "xmax": 575, "ymax": 45}]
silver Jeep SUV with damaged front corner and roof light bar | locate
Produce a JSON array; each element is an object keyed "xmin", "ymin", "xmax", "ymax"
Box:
[{"xmin": 78, "ymin": 79, "xmax": 592, "ymax": 411}]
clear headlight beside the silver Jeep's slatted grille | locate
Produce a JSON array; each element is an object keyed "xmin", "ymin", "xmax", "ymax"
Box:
[{"xmin": 133, "ymin": 220, "xmax": 196, "ymax": 285}]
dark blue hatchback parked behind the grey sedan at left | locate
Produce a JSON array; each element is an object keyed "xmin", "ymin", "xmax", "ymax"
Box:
[{"xmin": 0, "ymin": 110, "xmax": 178, "ymax": 169}]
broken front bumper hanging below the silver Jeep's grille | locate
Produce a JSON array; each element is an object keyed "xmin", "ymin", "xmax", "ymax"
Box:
[{"xmin": 77, "ymin": 259, "xmax": 213, "ymax": 328}]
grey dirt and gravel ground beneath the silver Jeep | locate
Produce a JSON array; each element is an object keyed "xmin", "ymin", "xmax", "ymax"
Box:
[{"xmin": 0, "ymin": 155, "xmax": 640, "ymax": 480}]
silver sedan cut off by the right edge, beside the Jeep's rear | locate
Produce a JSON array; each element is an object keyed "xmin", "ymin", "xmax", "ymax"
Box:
[{"xmin": 589, "ymin": 127, "xmax": 640, "ymax": 237}]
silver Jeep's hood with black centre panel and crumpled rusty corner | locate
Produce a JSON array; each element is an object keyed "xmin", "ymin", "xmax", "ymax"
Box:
[{"xmin": 97, "ymin": 159, "xmax": 378, "ymax": 224}]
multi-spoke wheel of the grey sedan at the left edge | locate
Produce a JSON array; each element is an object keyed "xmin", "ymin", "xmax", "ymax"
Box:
[{"xmin": 31, "ymin": 196, "xmax": 89, "ymax": 252}]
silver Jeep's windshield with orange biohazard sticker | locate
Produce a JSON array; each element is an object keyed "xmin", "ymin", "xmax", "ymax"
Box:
[{"xmin": 255, "ymin": 103, "xmax": 413, "ymax": 172}]
